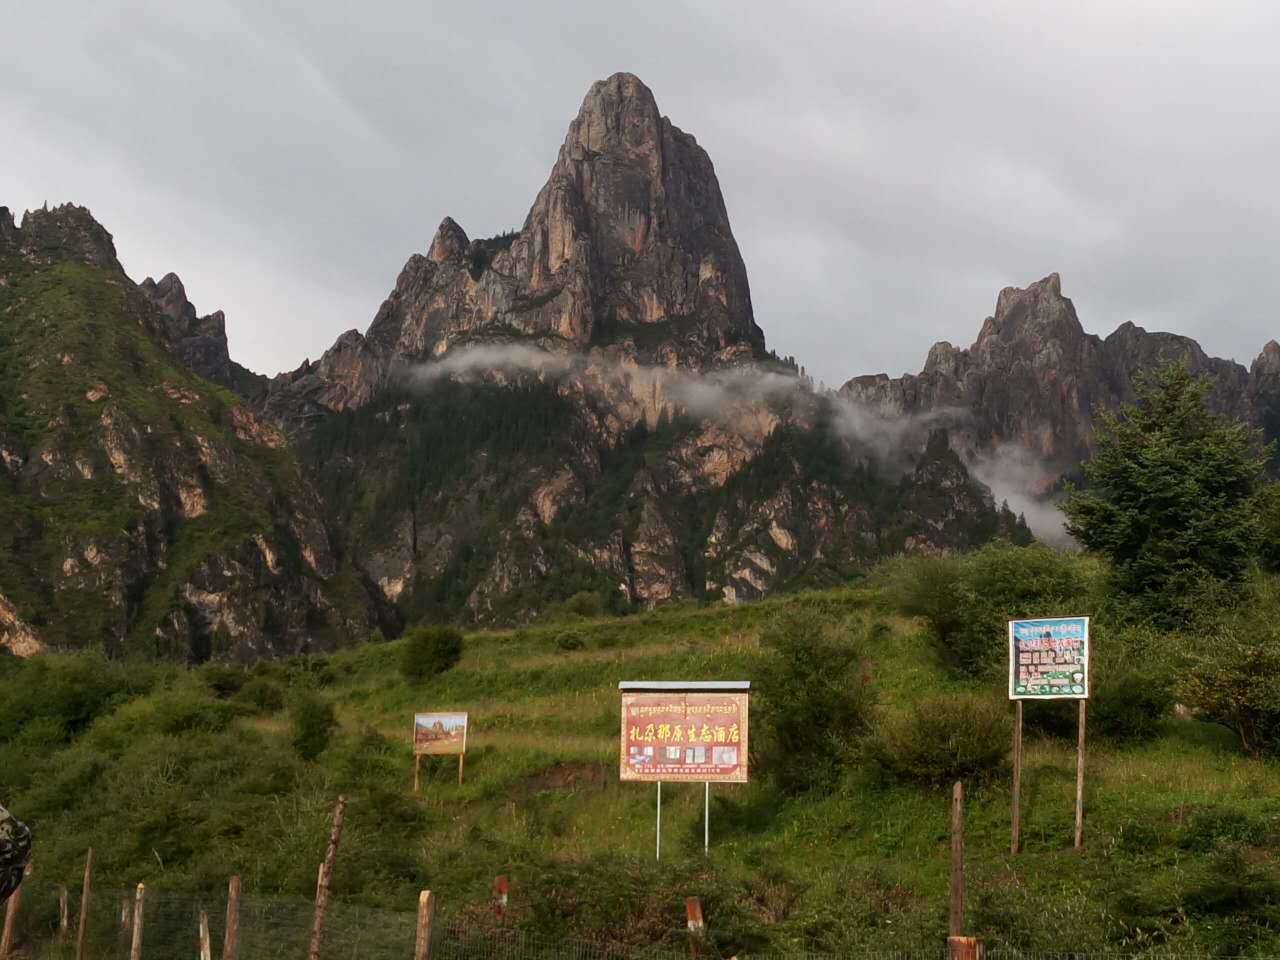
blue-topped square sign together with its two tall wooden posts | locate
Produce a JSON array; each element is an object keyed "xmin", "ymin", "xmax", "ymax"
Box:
[{"xmin": 1009, "ymin": 617, "xmax": 1091, "ymax": 854}]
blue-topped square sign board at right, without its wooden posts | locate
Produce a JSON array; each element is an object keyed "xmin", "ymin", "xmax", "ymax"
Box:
[{"xmin": 1009, "ymin": 617, "xmax": 1089, "ymax": 700}]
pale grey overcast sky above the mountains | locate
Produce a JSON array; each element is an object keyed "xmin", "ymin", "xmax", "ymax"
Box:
[{"xmin": 0, "ymin": 0, "xmax": 1280, "ymax": 384}]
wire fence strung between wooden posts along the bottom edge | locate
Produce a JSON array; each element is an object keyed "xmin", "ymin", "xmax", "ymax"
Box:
[{"xmin": 0, "ymin": 879, "xmax": 1280, "ymax": 960}]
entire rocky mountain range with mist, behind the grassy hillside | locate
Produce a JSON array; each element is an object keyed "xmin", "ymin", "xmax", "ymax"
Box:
[{"xmin": 0, "ymin": 74, "xmax": 1280, "ymax": 660}]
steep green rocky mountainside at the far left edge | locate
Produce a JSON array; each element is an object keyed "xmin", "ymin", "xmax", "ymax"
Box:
[{"xmin": 0, "ymin": 207, "xmax": 367, "ymax": 659}]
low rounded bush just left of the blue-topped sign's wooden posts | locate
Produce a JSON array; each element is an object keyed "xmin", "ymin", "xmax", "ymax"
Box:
[{"xmin": 872, "ymin": 694, "xmax": 1012, "ymax": 785}]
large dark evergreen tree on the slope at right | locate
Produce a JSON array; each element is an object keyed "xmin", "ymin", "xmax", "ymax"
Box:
[{"xmin": 1062, "ymin": 364, "xmax": 1270, "ymax": 621}]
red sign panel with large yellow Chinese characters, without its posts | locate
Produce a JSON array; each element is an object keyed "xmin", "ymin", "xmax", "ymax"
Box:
[{"xmin": 618, "ymin": 692, "xmax": 748, "ymax": 783}]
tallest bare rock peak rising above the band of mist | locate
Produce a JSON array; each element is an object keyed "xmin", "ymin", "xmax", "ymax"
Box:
[{"xmin": 268, "ymin": 73, "xmax": 764, "ymax": 431}]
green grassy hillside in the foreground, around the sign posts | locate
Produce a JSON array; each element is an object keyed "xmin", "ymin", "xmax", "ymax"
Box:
[{"xmin": 0, "ymin": 560, "xmax": 1280, "ymax": 956}]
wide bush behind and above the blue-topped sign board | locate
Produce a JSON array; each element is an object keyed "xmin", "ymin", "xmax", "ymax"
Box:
[{"xmin": 881, "ymin": 543, "xmax": 1096, "ymax": 678}]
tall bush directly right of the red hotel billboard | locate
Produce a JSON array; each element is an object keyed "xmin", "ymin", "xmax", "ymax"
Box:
[{"xmin": 759, "ymin": 609, "xmax": 872, "ymax": 794}]
